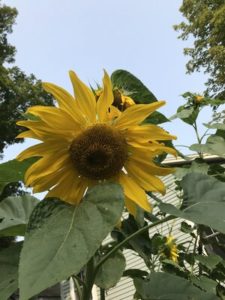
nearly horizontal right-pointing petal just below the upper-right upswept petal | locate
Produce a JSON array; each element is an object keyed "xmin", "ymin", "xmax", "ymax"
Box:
[{"xmin": 126, "ymin": 124, "xmax": 176, "ymax": 143}]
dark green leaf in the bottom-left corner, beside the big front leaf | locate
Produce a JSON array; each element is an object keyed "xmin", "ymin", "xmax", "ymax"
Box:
[{"xmin": 0, "ymin": 242, "xmax": 22, "ymax": 300}]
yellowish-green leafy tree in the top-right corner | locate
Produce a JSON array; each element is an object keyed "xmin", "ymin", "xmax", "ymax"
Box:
[{"xmin": 174, "ymin": 0, "xmax": 225, "ymax": 98}]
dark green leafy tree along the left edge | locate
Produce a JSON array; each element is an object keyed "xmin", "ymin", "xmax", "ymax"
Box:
[{"xmin": 0, "ymin": 0, "xmax": 53, "ymax": 154}]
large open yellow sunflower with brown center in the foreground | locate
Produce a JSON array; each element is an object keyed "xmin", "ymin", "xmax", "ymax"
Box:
[{"xmin": 17, "ymin": 71, "xmax": 175, "ymax": 215}]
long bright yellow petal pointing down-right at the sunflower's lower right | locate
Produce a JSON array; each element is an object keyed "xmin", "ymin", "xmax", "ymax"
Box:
[{"xmin": 119, "ymin": 172, "xmax": 151, "ymax": 211}]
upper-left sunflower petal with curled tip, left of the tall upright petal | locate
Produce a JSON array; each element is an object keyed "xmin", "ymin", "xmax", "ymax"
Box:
[{"xmin": 42, "ymin": 82, "xmax": 85, "ymax": 124}]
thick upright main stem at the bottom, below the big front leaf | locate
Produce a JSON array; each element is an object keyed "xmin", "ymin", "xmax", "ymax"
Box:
[{"xmin": 81, "ymin": 257, "xmax": 95, "ymax": 300}]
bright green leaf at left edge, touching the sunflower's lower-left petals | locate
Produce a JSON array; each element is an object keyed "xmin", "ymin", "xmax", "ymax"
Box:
[{"xmin": 0, "ymin": 158, "xmax": 35, "ymax": 192}]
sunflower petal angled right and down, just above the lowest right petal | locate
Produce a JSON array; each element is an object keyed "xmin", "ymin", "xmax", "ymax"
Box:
[{"xmin": 125, "ymin": 162, "xmax": 165, "ymax": 194}]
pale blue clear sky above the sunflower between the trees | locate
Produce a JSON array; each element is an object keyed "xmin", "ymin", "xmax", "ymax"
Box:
[{"xmin": 3, "ymin": 0, "xmax": 210, "ymax": 161}]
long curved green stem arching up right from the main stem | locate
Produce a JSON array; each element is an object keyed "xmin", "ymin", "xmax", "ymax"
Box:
[{"xmin": 94, "ymin": 216, "xmax": 177, "ymax": 277}]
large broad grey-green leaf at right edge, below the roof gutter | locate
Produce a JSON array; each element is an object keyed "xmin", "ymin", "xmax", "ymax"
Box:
[{"xmin": 160, "ymin": 173, "xmax": 225, "ymax": 233}]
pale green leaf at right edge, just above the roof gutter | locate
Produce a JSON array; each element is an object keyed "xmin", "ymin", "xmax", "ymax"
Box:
[{"xmin": 189, "ymin": 135, "xmax": 225, "ymax": 157}]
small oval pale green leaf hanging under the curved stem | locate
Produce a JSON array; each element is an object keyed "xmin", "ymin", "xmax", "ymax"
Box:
[{"xmin": 95, "ymin": 251, "xmax": 126, "ymax": 289}]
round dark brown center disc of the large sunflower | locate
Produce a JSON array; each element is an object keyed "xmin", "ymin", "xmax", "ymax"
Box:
[{"xmin": 70, "ymin": 124, "xmax": 128, "ymax": 180}]
